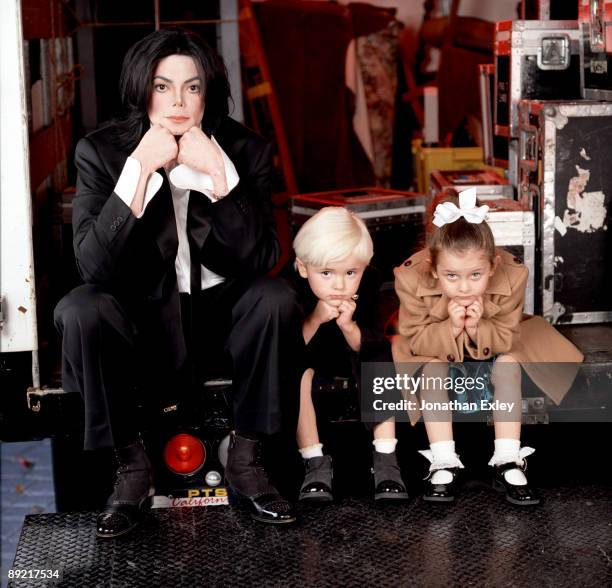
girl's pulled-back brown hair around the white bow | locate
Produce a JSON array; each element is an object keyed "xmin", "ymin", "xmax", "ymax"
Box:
[{"xmin": 427, "ymin": 189, "xmax": 495, "ymax": 268}]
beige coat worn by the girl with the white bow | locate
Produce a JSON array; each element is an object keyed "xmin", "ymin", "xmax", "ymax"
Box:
[{"xmin": 392, "ymin": 249, "xmax": 583, "ymax": 424}]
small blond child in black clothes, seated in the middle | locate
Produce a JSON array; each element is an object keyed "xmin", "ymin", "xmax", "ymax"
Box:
[{"xmin": 292, "ymin": 206, "xmax": 408, "ymax": 502}]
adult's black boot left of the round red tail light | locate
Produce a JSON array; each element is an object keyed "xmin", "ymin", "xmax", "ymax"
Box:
[{"xmin": 96, "ymin": 440, "xmax": 155, "ymax": 539}]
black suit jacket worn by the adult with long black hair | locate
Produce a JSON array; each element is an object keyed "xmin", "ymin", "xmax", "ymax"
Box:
[{"xmin": 72, "ymin": 118, "xmax": 280, "ymax": 368}]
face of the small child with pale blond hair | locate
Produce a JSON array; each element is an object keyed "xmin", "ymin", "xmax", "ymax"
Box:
[{"xmin": 297, "ymin": 255, "xmax": 367, "ymax": 306}]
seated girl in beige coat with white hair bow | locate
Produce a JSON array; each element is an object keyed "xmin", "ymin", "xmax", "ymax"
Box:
[{"xmin": 392, "ymin": 190, "xmax": 582, "ymax": 505}]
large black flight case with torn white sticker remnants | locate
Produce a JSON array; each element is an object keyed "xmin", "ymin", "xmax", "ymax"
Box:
[{"xmin": 520, "ymin": 101, "xmax": 612, "ymax": 324}]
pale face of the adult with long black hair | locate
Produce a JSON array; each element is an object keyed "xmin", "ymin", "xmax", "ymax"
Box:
[{"xmin": 148, "ymin": 55, "xmax": 204, "ymax": 135}]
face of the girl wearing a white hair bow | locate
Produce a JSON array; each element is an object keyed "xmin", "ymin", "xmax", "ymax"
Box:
[{"xmin": 433, "ymin": 249, "xmax": 497, "ymax": 306}]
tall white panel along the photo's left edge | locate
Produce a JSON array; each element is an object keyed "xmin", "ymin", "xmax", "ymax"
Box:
[{"xmin": 0, "ymin": 0, "xmax": 38, "ymax": 352}]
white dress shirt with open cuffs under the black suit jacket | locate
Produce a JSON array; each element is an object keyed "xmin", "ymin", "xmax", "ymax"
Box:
[{"xmin": 115, "ymin": 137, "xmax": 240, "ymax": 294}]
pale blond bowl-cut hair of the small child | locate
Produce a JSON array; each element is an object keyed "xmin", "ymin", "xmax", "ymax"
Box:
[{"xmin": 293, "ymin": 206, "xmax": 374, "ymax": 267}]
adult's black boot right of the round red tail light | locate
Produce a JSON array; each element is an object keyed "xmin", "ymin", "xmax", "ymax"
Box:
[{"xmin": 225, "ymin": 435, "xmax": 296, "ymax": 524}]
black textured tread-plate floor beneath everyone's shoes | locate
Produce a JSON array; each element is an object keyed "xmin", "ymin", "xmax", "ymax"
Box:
[{"xmin": 9, "ymin": 485, "xmax": 612, "ymax": 588}]
